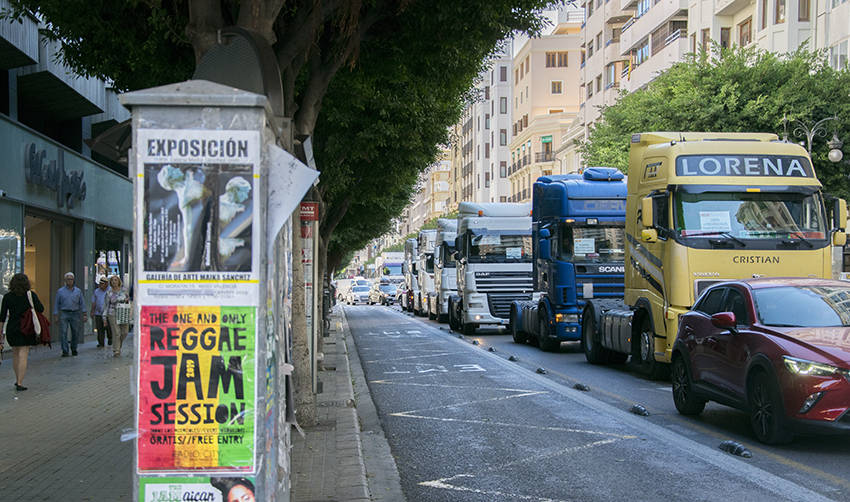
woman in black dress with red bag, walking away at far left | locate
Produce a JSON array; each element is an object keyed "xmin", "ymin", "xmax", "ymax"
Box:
[{"xmin": 0, "ymin": 274, "xmax": 44, "ymax": 391}]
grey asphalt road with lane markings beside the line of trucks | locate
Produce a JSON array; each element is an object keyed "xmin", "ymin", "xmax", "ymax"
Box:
[{"xmin": 345, "ymin": 306, "xmax": 850, "ymax": 501}]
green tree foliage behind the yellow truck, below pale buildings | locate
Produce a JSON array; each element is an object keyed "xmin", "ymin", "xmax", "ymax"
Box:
[{"xmin": 582, "ymin": 48, "xmax": 850, "ymax": 197}]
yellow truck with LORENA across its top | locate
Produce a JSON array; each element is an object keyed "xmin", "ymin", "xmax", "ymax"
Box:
[{"xmin": 582, "ymin": 132, "xmax": 847, "ymax": 378}]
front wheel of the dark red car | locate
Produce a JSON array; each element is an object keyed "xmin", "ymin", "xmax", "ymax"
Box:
[{"xmin": 747, "ymin": 371, "xmax": 793, "ymax": 444}]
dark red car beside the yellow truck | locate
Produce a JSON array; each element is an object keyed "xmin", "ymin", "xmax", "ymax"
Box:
[{"xmin": 671, "ymin": 278, "xmax": 850, "ymax": 444}]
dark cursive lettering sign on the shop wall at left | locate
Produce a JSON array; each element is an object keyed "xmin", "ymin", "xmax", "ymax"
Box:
[{"xmin": 24, "ymin": 143, "xmax": 86, "ymax": 209}]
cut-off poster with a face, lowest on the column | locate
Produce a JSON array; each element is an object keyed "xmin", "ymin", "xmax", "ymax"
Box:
[{"xmin": 139, "ymin": 476, "xmax": 257, "ymax": 502}]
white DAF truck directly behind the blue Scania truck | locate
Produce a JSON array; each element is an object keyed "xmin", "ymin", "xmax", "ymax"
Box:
[{"xmin": 449, "ymin": 202, "xmax": 533, "ymax": 336}]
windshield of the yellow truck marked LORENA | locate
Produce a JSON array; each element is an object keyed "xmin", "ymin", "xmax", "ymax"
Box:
[{"xmin": 674, "ymin": 191, "xmax": 827, "ymax": 242}]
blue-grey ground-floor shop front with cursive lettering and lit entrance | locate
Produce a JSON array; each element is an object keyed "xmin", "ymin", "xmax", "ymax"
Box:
[{"xmin": 0, "ymin": 115, "xmax": 133, "ymax": 334}]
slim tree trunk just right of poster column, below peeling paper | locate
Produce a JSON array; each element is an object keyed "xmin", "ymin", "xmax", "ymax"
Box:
[{"xmin": 292, "ymin": 205, "xmax": 319, "ymax": 427}]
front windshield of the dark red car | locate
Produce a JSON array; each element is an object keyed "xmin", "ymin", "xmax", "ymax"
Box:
[{"xmin": 753, "ymin": 286, "xmax": 850, "ymax": 327}]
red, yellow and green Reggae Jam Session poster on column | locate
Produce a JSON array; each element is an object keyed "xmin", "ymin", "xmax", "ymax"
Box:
[{"xmin": 136, "ymin": 306, "xmax": 257, "ymax": 474}]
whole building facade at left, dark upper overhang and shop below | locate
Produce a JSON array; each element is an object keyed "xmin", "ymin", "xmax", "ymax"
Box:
[{"xmin": 0, "ymin": 0, "xmax": 133, "ymax": 318}]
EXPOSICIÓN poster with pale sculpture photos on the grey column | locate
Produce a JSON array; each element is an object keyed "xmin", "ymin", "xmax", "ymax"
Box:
[{"xmin": 136, "ymin": 129, "xmax": 260, "ymax": 305}]
